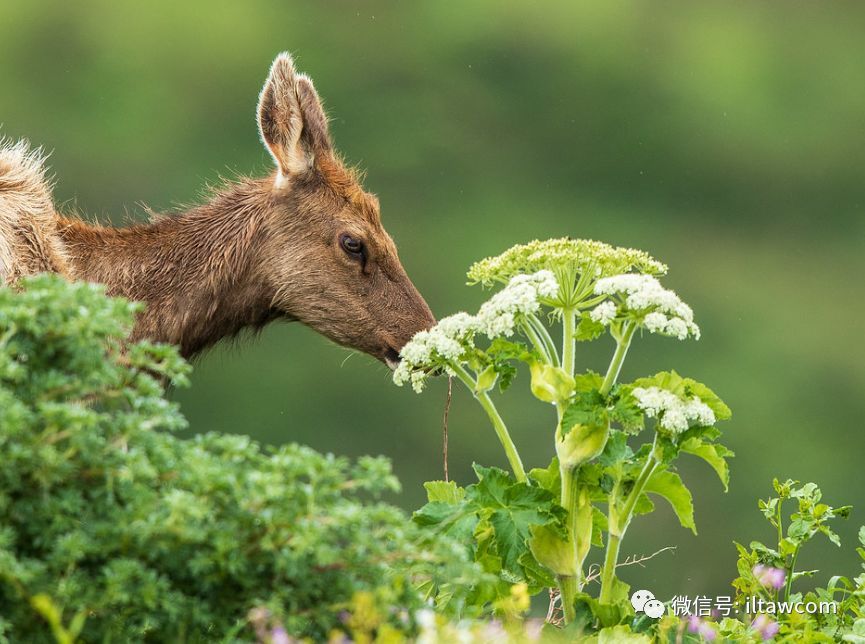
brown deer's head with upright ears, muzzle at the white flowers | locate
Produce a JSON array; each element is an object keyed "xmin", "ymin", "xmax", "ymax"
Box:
[{"xmin": 258, "ymin": 54, "xmax": 435, "ymax": 368}]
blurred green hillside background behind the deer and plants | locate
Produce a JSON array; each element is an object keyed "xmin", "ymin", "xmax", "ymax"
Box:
[{"xmin": 0, "ymin": 0, "xmax": 865, "ymax": 599}]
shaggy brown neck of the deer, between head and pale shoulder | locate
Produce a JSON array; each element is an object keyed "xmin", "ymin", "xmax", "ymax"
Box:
[{"xmin": 59, "ymin": 181, "xmax": 278, "ymax": 357}]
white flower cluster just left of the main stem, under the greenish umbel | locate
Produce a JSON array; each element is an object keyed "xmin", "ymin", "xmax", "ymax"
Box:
[{"xmin": 477, "ymin": 270, "xmax": 559, "ymax": 339}]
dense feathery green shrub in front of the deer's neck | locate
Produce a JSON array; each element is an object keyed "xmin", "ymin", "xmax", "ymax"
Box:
[{"xmin": 0, "ymin": 276, "xmax": 479, "ymax": 642}]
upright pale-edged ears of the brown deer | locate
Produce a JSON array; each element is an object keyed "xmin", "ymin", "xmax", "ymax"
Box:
[{"xmin": 258, "ymin": 53, "xmax": 330, "ymax": 184}]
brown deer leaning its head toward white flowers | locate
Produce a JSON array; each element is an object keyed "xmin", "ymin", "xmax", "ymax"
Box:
[{"xmin": 0, "ymin": 53, "xmax": 435, "ymax": 369}]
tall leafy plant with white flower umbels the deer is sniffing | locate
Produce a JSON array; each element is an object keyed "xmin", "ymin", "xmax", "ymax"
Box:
[{"xmin": 394, "ymin": 239, "xmax": 732, "ymax": 635}]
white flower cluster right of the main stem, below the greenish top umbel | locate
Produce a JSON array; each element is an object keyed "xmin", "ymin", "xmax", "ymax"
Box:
[{"xmin": 589, "ymin": 274, "xmax": 700, "ymax": 340}]
